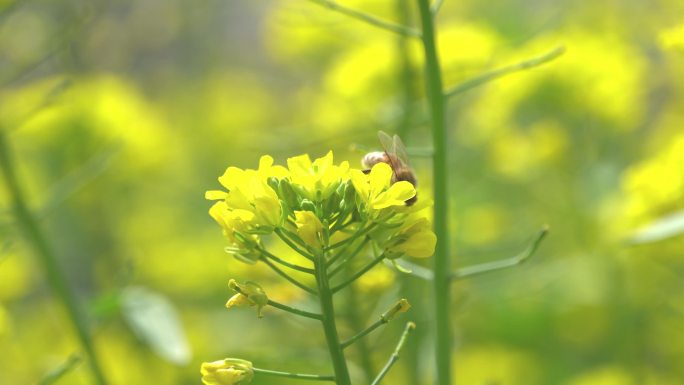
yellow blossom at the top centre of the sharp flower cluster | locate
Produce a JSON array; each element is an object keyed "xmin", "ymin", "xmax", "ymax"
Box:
[{"xmin": 287, "ymin": 151, "xmax": 349, "ymax": 202}]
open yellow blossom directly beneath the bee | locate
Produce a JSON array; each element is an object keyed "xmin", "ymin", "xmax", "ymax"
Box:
[{"xmin": 351, "ymin": 162, "xmax": 416, "ymax": 215}]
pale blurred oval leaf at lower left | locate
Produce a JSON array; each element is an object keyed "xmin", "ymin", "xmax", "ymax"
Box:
[{"xmin": 121, "ymin": 286, "xmax": 191, "ymax": 365}]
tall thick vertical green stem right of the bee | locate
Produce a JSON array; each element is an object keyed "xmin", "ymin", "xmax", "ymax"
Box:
[{"xmin": 417, "ymin": 0, "xmax": 451, "ymax": 385}]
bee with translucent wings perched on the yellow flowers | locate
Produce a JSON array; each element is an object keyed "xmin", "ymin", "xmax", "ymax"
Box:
[{"xmin": 361, "ymin": 131, "xmax": 418, "ymax": 206}]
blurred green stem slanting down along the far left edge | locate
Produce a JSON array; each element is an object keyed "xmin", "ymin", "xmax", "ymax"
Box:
[{"xmin": 0, "ymin": 129, "xmax": 107, "ymax": 385}]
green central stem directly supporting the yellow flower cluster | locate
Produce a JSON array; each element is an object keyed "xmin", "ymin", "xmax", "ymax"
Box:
[{"xmin": 314, "ymin": 254, "xmax": 351, "ymax": 385}]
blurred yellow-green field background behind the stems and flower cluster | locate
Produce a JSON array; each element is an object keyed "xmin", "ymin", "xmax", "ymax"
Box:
[{"xmin": 0, "ymin": 0, "xmax": 684, "ymax": 385}]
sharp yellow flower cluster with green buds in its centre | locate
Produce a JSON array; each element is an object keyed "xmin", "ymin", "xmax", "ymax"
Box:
[{"xmin": 206, "ymin": 152, "xmax": 436, "ymax": 263}]
